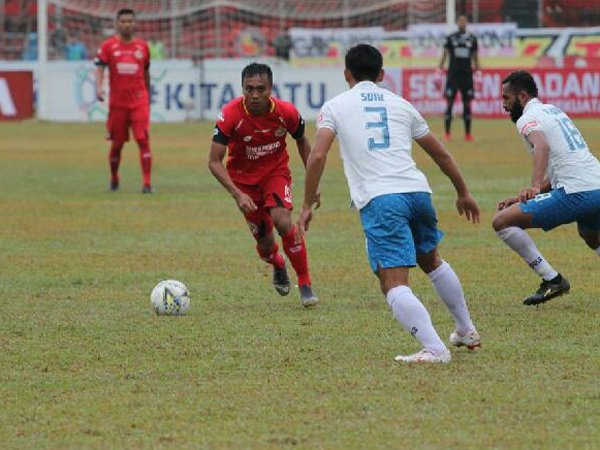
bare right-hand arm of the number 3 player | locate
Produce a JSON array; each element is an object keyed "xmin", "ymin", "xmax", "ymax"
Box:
[{"xmin": 415, "ymin": 132, "xmax": 479, "ymax": 223}]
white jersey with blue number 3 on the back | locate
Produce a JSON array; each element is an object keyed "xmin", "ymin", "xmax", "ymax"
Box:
[{"xmin": 317, "ymin": 81, "xmax": 431, "ymax": 209}]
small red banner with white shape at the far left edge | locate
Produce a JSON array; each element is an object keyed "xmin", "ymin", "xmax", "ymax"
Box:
[{"xmin": 0, "ymin": 71, "xmax": 33, "ymax": 121}]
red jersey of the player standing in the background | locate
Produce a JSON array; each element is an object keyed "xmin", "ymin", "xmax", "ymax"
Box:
[{"xmin": 95, "ymin": 36, "xmax": 150, "ymax": 108}]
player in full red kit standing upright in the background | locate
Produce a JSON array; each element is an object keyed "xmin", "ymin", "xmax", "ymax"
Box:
[{"xmin": 95, "ymin": 9, "xmax": 152, "ymax": 194}]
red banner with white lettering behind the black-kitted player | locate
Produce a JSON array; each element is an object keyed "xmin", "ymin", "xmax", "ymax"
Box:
[{"xmin": 401, "ymin": 68, "xmax": 600, "ymax": 117}]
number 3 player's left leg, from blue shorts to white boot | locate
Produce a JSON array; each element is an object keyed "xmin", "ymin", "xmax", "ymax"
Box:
[{"xmin": 360, "ymin": 194, "xmax": 450, "ymax": 362}]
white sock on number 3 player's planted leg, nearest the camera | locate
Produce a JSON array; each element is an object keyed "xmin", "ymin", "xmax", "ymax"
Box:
[{"xmin": 385, "ymin": 286, "xmax": 447, "ymax": 354}]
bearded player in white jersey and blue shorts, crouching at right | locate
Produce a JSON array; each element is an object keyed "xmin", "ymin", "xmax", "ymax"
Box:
[{"xmin": 493, "ymin": 71, "xmax": 600, "ymax": 305}]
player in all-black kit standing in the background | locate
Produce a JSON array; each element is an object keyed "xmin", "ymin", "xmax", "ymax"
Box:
[{"xmin": 439, "ymin": 16, "xmax": 479, "ymax": 141}]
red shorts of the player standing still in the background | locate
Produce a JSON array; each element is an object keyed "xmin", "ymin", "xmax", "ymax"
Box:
[{"xmin": 106, "ymin": 105, "xmax": 150, "ymax": 142}]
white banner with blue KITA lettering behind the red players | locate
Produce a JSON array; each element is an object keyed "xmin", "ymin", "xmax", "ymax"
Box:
[{"xmin": 29, "ymin": 59, "xmax": 346, "ymax": 122}]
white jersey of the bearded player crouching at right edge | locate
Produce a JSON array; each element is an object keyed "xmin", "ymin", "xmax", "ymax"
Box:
[{"xmin": 517, "ymin": 98, "xmax": 600, "ymax": 194}]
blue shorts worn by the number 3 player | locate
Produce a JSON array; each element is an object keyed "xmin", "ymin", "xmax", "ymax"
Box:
[{"xmin": 360, "ymin": 192, "xmax": 444, "ymax": 273}]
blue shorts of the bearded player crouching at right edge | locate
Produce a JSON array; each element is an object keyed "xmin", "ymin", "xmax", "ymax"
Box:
[{"xmin": 520, "ymin": 188, "xmax": 600, "ymax": 231}]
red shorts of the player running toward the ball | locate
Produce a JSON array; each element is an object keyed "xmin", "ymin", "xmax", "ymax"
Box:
[{"xmin": 236, "ymin": 174, "xmax": 293, "ymax": 238}]
